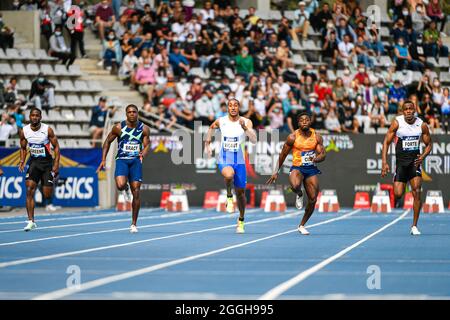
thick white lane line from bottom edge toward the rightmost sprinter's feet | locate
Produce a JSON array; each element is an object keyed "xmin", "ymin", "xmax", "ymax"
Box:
[{"xmin": 259, "ymin": 210, "xmax": 409, "ymax": 300}]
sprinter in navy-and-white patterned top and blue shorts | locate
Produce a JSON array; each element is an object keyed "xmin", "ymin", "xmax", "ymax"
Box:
[{"xmin": 97, "ymin": 104, "xmax": 150, "ymax": 233}]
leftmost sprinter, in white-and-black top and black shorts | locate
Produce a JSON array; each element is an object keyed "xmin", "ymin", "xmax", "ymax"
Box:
[{"xmin": 19, "ymin": 108, "xmax": 60, "ymax": 231}]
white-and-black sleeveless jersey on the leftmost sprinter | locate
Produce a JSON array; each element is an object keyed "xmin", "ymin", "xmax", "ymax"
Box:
[{"xmin": 23, "ymin": 123, "xmax": 52, "ymax": 161}]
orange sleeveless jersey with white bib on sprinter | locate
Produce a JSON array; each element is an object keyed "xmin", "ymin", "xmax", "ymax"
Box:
[{"xmin": 292, "ymin": 129, "xmax": 317, "ymax": 167}]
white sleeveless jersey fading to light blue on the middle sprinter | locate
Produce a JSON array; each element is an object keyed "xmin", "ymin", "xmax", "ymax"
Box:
[{"xmin": 219, "ymin": 115, "xmax": 245, "ymax": 164}]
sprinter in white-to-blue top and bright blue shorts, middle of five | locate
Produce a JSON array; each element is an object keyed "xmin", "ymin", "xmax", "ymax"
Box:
[{"xmin": 205, "ymin": 99, "xmax": 256, "ymax": 233}]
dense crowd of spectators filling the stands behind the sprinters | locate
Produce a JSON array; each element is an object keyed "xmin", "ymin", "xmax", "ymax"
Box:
[{"xmin": 2, "ymin": 0, "xmax": 450, "ymax": 133}]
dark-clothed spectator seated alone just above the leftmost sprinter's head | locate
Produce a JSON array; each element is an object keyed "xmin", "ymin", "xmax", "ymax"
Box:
[{"xmin": 28, "ymin": 72, "xmax": 55, "ymax": 109}]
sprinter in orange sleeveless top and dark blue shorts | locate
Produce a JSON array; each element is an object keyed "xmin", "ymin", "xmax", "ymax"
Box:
[{"xmin": 267, "ymin": 112, "xmax": 325, "ymax": 235}]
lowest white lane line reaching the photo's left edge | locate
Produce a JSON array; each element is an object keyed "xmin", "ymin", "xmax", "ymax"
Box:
[{"xmin": 0, "ymin": 210, "xmax": 298, "ymax": 268}]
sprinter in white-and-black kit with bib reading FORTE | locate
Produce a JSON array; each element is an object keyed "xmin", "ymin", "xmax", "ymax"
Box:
[{"xmin": 381, "ymin": 101, "xmax": 432, "ymax": 235}]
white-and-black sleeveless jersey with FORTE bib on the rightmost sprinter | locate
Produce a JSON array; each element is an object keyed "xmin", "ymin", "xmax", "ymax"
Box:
[{"xmin": 395, "ymin": 116, "xmax": 423, "ymax": 166}]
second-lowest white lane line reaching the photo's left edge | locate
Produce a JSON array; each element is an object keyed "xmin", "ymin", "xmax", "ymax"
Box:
[{"xmin": 0, "ymin": 209, "xmax": 257, "ymax": 247}]
